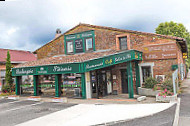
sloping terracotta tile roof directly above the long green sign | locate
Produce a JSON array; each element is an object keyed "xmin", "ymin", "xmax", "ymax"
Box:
[{"xmin": 16, "ymin": 50, "xmax": 121, "ymax": 68}]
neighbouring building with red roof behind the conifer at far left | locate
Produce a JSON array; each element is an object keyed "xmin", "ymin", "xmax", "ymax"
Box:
[{"xmin": 0, "ymin": 49, "xmax": 37, "ymax": 91}]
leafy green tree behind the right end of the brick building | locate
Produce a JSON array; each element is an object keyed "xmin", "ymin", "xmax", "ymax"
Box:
[{"xmin": 155, "ymin": 21, "xmax": 190, "ymax": 64}]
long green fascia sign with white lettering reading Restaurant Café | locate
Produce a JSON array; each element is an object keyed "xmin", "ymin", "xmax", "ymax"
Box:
[{"xmin": 12, "ymin": 50, "xmax": 142, "ymax": 76}]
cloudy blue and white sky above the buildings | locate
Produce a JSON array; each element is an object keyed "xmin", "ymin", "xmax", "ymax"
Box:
[{"xmin": 0, "ymin": 0, "xmax": 190, "ymax": 51}]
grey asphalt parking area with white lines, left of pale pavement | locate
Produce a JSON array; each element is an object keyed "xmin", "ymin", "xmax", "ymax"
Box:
[{"xmin": 0, "ymin": 99, "xmax": 75, "ymax": 126}]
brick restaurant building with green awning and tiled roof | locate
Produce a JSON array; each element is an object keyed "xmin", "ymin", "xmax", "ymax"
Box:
[{"xmin": 13, "ymin": 24, "xmax": 188, "ymax": 98}]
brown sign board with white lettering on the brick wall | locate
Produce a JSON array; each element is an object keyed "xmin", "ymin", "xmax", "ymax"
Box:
[{"xmin": 143, "ymin": 43, "xmax": 177, "ymax": 60}]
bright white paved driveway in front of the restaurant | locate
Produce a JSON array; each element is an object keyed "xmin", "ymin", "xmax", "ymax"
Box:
[{"xmin": 17, "ymin": 103, "xmax": 175, "ymax": 126}]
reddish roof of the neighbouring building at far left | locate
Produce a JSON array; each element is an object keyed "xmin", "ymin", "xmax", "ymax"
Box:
[{"xmin": 0, "ymin": 49, "xmax": 37, "ymax": 63}]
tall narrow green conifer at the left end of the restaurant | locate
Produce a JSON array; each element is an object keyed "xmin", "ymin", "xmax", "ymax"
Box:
[{"xmin": 4, "ymin": 51, "xmax": 13, "ymax": 92}]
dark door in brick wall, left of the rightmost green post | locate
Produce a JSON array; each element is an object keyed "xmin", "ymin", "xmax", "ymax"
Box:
[{"xmin": 121, "ymin": 69, "xmax": 128, "ymax": 93}]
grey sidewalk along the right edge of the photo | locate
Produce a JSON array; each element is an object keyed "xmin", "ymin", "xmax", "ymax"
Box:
[{"xmin": 179, "ymin": 72, "xmax": 190, "ymax": 126}]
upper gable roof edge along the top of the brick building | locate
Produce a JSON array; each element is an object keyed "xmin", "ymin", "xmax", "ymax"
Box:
[{"xmin": 34, "ymin": 23, "xmax": 187, "ymax": 53}]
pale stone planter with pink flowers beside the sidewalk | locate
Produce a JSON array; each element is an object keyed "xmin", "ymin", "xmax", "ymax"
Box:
[{"xmin": 156, "ymin": 94, "xmax": 177, "ymax": 102}]
